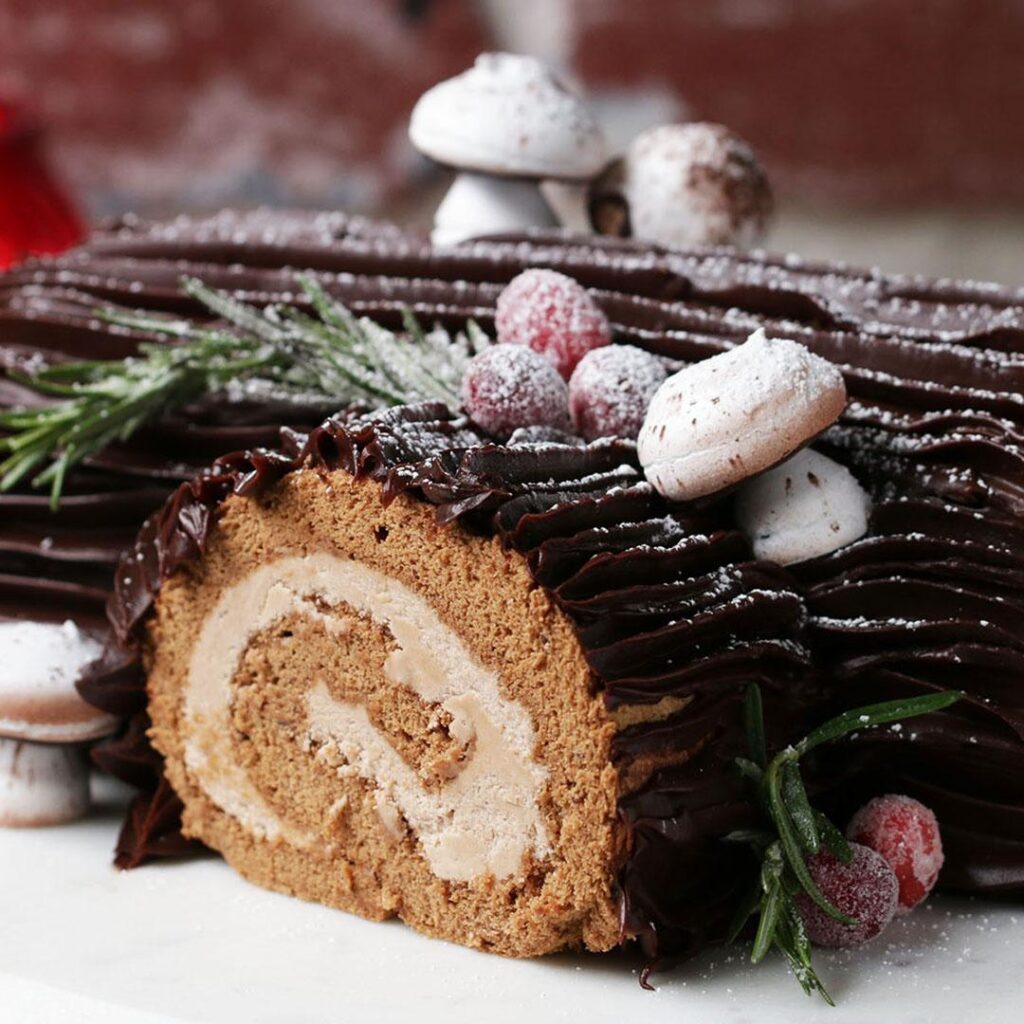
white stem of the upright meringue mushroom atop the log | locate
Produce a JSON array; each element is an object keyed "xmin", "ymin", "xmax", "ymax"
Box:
[{"xmin": 431, "ymin": 171, "xmax": 557, "ymax": 246}]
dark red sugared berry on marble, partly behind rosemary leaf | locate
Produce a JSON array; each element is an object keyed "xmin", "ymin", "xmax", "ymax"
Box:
[{"xmin": 794, "ymin": 843, "xmax": 899, "ymax": 949}]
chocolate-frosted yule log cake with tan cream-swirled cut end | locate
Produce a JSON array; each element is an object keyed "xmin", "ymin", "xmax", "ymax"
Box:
[{"xmin": 0, "ymin": 199, "xmax": 1024, "ymax": 974}]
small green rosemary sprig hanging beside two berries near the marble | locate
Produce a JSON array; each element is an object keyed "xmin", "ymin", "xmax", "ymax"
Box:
[{"xmin": 726, "ymin": 685, "xmax": 963, "ymax": 1006}]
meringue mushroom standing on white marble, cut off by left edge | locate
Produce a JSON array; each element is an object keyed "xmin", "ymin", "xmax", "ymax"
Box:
[{"xmin": 0, "ymin": 620, "xmax": 117, "ymax": 826}]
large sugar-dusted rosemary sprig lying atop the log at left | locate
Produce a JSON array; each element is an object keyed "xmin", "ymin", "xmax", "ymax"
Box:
[{"xmin": 0, "ymin": 275, "xmax": 489, "ymax": 508}]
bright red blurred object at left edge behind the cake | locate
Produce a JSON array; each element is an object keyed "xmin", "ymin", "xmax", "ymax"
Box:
[{"xmin": 0, "ymin": 102, "xmax": 84, "ymax": 268}]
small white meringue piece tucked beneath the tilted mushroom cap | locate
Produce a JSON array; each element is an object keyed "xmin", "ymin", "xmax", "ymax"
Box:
[{"xmin": 735, "ymin": 449, "xmax": 871, "ymax": 565}]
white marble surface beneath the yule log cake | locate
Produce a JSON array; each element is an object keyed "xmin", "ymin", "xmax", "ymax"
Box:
[{"xmin": 0, "ymin": 778, "xmax": 1024, "ymax": 1024}]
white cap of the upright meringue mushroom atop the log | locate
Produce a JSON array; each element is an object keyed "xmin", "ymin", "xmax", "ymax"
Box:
[{"xmin": 409, "ymin": 53, "xmax": 607, "ymax": 180}]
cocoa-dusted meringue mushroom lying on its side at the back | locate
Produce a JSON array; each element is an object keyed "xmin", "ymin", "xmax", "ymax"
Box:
[{"xmin": 590, "ymin": 122, "xmax": 772, "ymax": 248}]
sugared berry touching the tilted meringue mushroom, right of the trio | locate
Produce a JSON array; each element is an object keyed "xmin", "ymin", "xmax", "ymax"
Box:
[{"xmin": 569, "ymin": 345, "xmax": 668, "ymax": 441}]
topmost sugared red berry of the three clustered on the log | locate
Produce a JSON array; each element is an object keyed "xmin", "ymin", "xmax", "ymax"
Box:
[{"xmin": 495, "ymin": 269, "xmax": 611, "ymax": 380}]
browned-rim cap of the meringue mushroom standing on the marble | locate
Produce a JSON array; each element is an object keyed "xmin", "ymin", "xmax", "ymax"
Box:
[{"xmin": 0, "ymin": 620, "xmax": 118, "ymax": 743}]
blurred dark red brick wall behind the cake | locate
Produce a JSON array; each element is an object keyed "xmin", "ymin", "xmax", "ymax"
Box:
[{"xmin": 0, "ymin": 0, "xmax": 1024, "ymax": 276}]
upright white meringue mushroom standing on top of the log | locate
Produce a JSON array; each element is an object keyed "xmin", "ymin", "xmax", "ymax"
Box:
[{"xmin": 409, "ymin": 53, "xmax": 607, "ymax": 245}]
